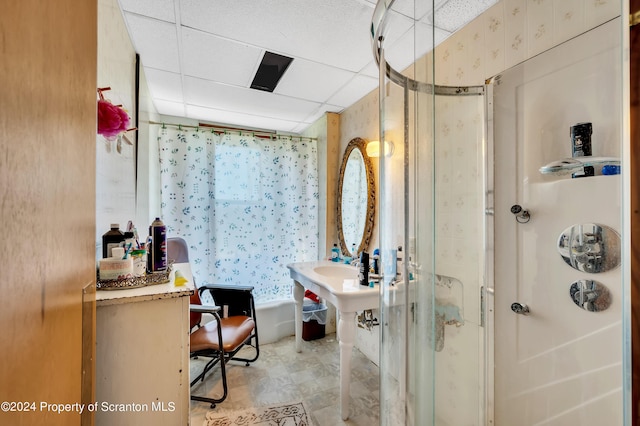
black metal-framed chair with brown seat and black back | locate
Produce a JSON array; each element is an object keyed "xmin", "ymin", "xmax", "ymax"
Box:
[{"xmin": 167, "ymin": 237, "xmax": 260, "ymax": 408}]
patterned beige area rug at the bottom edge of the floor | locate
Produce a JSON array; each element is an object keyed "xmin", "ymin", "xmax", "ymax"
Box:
[{"xmin": 203, "ymin": 401, "xmax": 312, "ymax": 426}]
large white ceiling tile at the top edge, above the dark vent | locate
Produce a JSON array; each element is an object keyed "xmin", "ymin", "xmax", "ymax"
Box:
[{"xmin": 181, "ymin": 0, "xmax": 373, "ymax": 72}]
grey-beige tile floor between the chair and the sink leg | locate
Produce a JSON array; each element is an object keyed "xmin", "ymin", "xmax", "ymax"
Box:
[{"xmin": 191, "ymin": 334, "xmax": 379, "ymax": 426}]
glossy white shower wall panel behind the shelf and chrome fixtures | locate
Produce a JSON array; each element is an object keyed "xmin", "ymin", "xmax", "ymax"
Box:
[{"xmin": 494, "ymin": 19, "xmax": 623, "ymax": 426}]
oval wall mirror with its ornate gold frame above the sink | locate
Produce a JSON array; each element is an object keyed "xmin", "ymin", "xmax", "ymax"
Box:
[{"xmin": 338, "ymin": 138, "xmax": 375, "ymax": 256}]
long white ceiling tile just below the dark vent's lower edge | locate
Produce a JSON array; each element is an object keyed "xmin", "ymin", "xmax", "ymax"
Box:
[{"xmin": 184, "ymin": 77, "xmax": 319, "ymax": 120}]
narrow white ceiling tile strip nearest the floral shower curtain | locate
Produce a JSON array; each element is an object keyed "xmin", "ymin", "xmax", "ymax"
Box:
[{"xmin": 187, "ymin": 105, "xmax": 298, "ymax": 132}]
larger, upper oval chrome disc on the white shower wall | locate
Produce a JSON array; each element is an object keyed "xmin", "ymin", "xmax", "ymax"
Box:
[{"xmin": 558, "ymin": 223, "xmax": 621, "ymax": 273}]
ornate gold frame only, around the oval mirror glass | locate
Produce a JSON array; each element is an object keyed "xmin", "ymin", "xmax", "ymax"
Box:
[{"xmin": 338, "ymin": 138, "xmax": 376, "ymax": 255}]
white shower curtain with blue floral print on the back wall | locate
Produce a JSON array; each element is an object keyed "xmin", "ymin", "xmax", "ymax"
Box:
[{"xmin": 159, "ymin": 129, "xmax": 318, "ymax": 303}]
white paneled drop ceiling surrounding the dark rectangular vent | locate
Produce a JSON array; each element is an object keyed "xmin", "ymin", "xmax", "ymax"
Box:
[{"xmin": 119, "ymin": 0, "xmax": 496, "ymax": 134}]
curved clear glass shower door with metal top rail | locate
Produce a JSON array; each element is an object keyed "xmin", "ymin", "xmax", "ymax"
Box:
[{"xmin": 373, "ymin": 1, "xmax": 486, "ymax": 426}]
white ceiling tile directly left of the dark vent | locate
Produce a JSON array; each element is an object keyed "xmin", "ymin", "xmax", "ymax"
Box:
[{"xmin": 182, "ymin": 28, "xmax": 263, "ymax": 87}]
